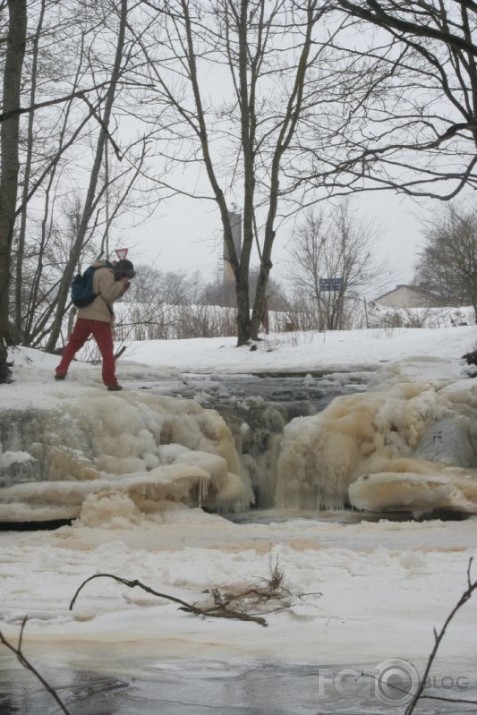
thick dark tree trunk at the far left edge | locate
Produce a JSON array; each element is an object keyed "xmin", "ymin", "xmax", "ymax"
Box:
[{"xmin": 0, "ymin": 0, "xmax": 27, "ymax": 383}]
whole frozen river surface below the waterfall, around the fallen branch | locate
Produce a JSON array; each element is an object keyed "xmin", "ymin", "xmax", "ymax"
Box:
[{"xmin": 0, "ymin": 510, "xmax": 477, "ymax": 715}]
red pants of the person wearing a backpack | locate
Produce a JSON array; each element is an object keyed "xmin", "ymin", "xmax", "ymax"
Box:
[{"xmin": 56, "ymin": 318, "xmax": 116, "ymax": 385}]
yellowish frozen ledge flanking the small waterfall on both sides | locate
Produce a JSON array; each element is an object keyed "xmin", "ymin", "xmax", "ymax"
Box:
[{"xmin": 0, "ymin": 358, "xmax": 477, "ymax": 523}]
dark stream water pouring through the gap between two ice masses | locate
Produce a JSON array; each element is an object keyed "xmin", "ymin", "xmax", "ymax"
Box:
[{"xmin": 138, "ymin": 370, "xmax": 375, "ymax": 509}]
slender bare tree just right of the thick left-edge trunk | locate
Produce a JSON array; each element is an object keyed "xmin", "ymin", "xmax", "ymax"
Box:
[{"xmin": 11, "ymin": 0, "xmax": 105, "ymax": 345}]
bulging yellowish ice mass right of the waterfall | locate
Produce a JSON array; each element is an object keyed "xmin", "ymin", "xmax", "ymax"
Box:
[{"xmin": 276, "ymin": 360, "xmax": 477, "ymax": 513}]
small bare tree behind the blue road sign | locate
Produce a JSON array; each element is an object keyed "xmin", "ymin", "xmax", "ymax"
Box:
[{"xmin": 291, "ymin": 201, "xmax": 383, "ymax": 330}]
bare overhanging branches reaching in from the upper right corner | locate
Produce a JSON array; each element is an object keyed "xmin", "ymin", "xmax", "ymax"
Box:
[{"xmin": 320, "ymin": 0, "xmax": 477, "ymax": 200}]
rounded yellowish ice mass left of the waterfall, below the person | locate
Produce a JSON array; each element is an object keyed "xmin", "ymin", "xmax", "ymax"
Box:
[{"xmin": 0, "ymin": 392, "xmax": 252, "ymax": 522}]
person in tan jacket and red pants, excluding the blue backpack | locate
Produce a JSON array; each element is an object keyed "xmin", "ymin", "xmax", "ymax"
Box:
[{"xmin": 55, "ymin": 259, "xmax": 136, "ymax": 391}]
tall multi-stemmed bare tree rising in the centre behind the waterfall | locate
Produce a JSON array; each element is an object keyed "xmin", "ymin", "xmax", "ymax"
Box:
[{"xmin": 130, "ymin": 0, "xmax": 340, "ymax": 345}]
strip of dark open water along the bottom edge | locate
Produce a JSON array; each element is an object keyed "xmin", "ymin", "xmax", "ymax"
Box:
[{"xmin": 0, "ymin": 661, "xmax": 477, "ymax": 715}]
